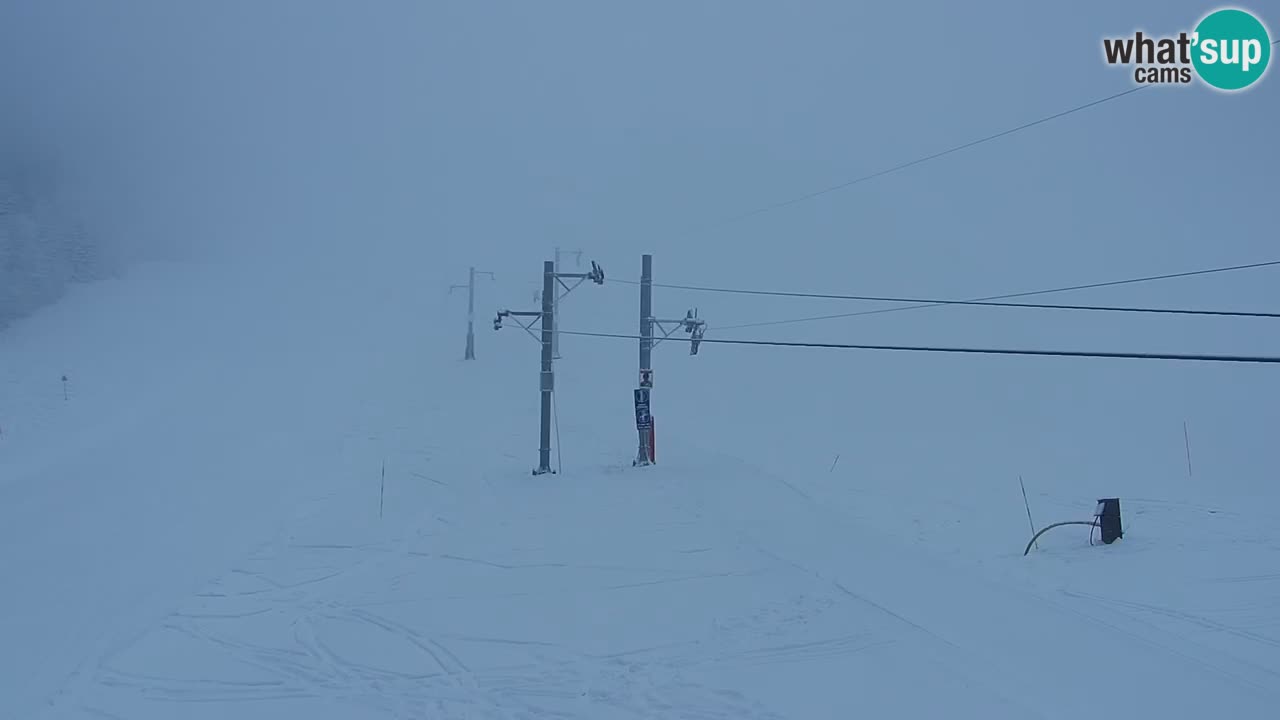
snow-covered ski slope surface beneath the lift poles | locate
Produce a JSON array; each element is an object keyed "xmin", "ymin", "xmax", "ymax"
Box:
[{"xmin": 0, "ymin": 260, "xmax": 1280, "ymax": 720}]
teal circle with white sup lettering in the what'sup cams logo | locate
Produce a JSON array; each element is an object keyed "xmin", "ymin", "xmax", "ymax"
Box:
[{"xmin": 1192, "ymin": 9, "xmax": 1271, "ymax": 91}]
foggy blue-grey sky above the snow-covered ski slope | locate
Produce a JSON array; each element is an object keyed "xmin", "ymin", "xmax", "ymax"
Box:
[{"xmin": 0, "ymin": 0, "xmax": 1280, "ymax": 499}]
